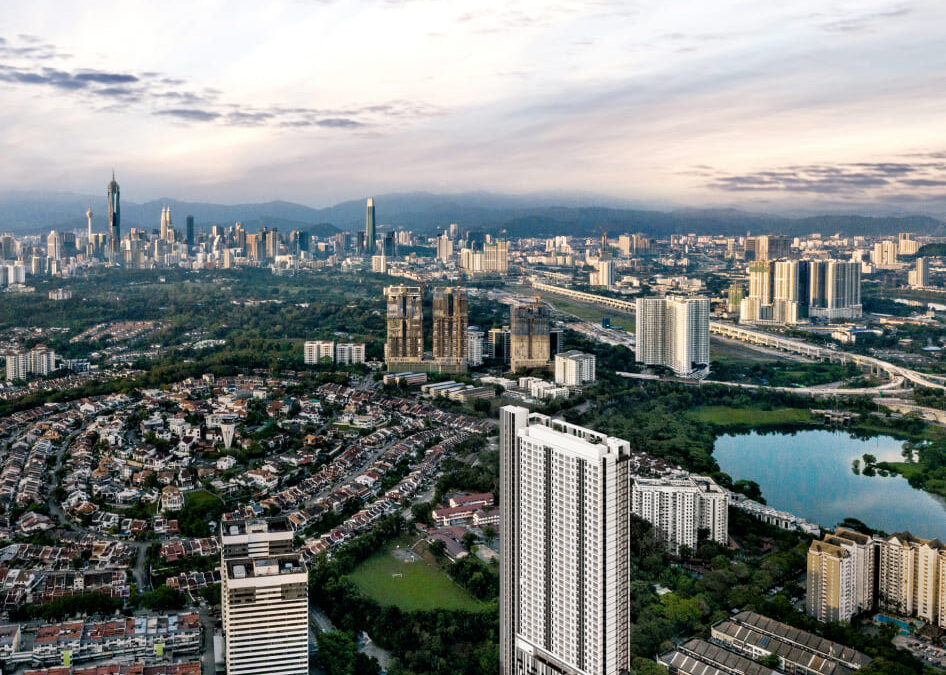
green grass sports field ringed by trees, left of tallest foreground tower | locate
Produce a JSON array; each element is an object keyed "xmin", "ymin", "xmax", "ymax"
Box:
[{"xmin": 348, "ymin": 539, "xmax": 485, "ymax": 611}]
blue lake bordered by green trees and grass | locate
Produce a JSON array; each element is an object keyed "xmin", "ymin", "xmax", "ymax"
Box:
[{"xmin": 713, "ymin": 431, "xmax": 946, "ymax": 539}]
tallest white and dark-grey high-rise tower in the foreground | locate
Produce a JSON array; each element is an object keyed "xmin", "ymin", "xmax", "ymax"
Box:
[{"xmin": 500, "ymin": 406, "xmax": 630, "ymax": 675}]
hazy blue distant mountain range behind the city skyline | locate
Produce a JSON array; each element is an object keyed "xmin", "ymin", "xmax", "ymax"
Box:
[{"xmin": 0, "ymin": 192, "xmax": 946, "ymax": 237}]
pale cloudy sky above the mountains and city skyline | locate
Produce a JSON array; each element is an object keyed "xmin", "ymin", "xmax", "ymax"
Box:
[{"xmin": 0, "ymin": 0, "xmax": 946, "ymax": 212}]
